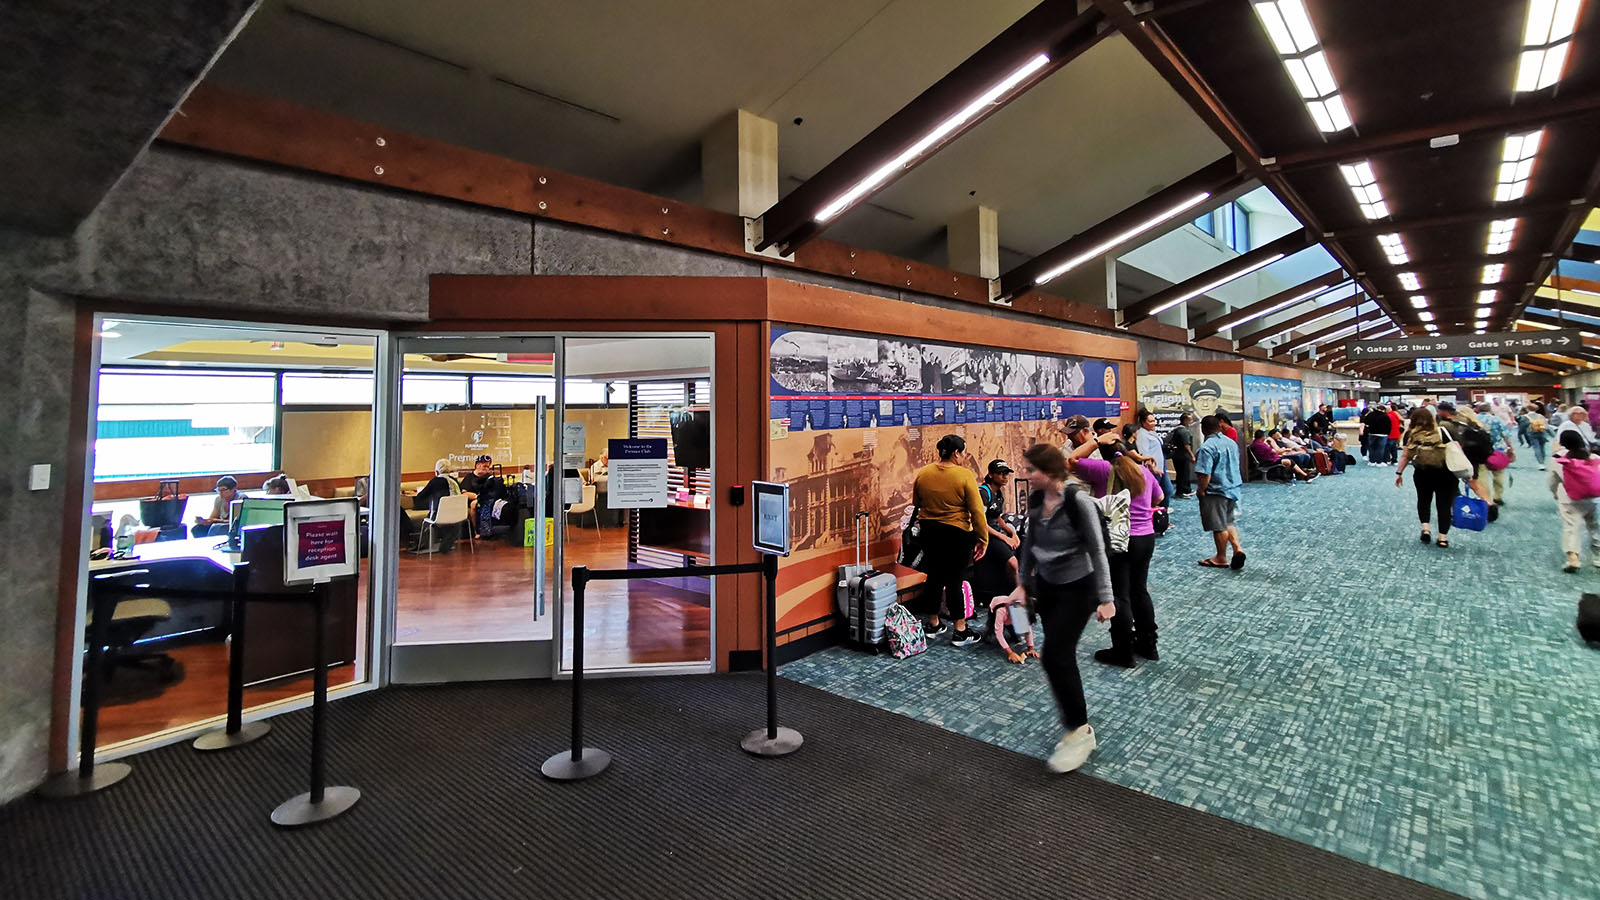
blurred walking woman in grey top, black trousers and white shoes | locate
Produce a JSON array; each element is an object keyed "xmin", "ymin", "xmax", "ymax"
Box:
[{"xmin": 1011, "ymin": 444, "xmax": 1117, "ymax": 773}]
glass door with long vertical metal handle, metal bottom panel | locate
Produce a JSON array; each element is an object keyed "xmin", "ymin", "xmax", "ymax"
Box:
[{"xmin": 387, "ymin": 336, "xmax": 562, "ymax": 684}]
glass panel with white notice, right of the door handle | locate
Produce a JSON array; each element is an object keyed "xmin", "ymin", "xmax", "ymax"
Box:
[{"xmin": 557, "ymin": 335, "xmax": 717, "ymax": 673}]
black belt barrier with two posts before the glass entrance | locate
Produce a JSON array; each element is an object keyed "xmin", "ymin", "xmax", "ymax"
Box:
[{"xmin": 541, "ymin": 556, "xmax": 805, "ymax": 781}]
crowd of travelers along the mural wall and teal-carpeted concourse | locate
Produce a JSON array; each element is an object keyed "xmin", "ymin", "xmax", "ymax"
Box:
[{"xmin": 909, "ymin": 400, "xmax": 1600, "ymax": 773}]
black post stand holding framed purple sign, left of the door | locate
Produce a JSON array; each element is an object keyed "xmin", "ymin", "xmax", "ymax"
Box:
[{"xmin": 272, "ymin": 498, "xmax": 362, "ymax": 828}]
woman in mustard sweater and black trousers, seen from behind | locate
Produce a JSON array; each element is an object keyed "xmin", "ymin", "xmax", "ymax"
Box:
[{"xmin": 912, "ymin": 434, "xmax": 989, "ymax": 647}]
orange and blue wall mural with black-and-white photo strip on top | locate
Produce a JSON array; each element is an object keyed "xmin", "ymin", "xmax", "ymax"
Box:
[{"xmin": 768, "ymin": 327, "xmax": 1122, "ymax": 629}]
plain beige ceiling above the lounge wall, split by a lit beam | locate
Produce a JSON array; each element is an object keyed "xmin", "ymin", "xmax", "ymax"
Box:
[{"xmin": 211, "ymin": 0, "xmax": 1226, "ymax": 263}]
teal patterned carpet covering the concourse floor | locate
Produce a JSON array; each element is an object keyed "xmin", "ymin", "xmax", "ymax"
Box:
[{"xmin": 782, "ymin": 458, "xmax": 1600, "ymax": 898}]
